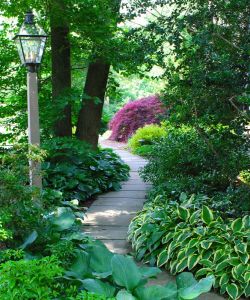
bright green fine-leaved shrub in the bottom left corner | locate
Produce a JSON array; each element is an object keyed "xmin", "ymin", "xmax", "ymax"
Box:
[{"xmin": 0, "ymin": 257, "xmax": 63, "ymax": 300}]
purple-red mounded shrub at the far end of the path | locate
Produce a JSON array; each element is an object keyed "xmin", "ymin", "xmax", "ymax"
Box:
[{"xmin": 109, "ymin": 96, "xmax": 166, "ymax": 142}]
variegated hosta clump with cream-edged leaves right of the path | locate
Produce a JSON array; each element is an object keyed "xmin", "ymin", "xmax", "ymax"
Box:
[{"xmin": 129, "ymin": 196, "xmax": 250, "ymax": 299}]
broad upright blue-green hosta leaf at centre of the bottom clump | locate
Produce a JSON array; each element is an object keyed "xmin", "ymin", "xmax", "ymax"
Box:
[{"xmin": 111, "ymin": 254, "xmax": 142, "ymax": 291}]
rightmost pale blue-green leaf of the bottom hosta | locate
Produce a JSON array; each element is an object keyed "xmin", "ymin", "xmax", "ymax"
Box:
[{"xmin": 178, "ymin": 276, "xmax": 215, "ymax": 299}]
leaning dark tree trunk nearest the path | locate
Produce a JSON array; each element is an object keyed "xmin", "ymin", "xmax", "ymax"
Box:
[{"xmin": 76, "ymin": 60, "xmax": 110, "ymax": 148}]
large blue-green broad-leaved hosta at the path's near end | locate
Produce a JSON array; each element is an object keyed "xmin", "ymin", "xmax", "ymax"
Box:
[{"xmin": 64, "ymin": 241, "xmax": 214, "ymax": 300}]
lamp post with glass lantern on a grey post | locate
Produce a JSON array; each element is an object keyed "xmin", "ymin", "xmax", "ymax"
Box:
[{"xmin": 14, "ymin": 11, "xmax": 47, "ymax": 188}]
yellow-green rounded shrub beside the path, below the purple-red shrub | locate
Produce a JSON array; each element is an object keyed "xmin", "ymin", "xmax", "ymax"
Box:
[{"xmin": 128, "ymin": 124, "xmax": 166, "ymax": 154}]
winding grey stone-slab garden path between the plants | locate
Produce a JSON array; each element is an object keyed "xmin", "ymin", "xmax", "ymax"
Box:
[{"xmin": 84, "ymin": 140, "xmax": 225, "ymax": 300}]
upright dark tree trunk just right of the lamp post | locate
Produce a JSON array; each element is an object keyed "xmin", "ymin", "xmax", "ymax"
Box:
[{"xmin": 51, "ymin": 0, "xmax": 72, "ymax": 136}]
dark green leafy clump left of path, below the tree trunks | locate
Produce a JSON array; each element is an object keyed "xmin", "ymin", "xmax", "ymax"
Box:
[{"xmin": 43, "ymin": 138, "xmax": 129, "ymax": 200}]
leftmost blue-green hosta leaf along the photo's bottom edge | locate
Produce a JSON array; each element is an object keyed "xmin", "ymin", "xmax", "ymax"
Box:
[{"xmin": 81, "ymin": 278, "xmax": 115, "ymax": 297}]
